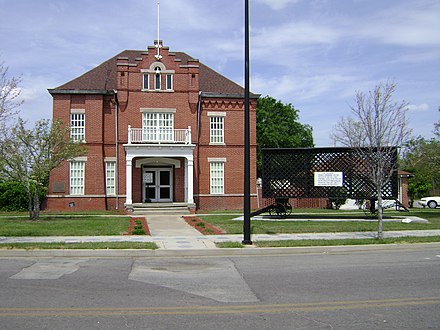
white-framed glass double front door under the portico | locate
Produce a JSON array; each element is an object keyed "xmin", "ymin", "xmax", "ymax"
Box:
[{"xmin": 142, "ymin": 167, "xmax": 173, "ymax": 203}]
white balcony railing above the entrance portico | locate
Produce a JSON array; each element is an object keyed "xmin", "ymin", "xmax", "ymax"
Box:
[{"xmin": 128, "ymin": 125, "xmax": 191, "ymax": 144}]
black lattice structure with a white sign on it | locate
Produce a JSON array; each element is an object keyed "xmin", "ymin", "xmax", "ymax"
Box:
[{"xmin": 262, "ymin": 147, "xmax": 398, "ymax": 199}]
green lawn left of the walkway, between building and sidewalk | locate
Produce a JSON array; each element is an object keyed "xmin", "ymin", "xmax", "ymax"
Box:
[{"xmin": 0, "ymin": 214, "xmax": 130, "ymax": 236}]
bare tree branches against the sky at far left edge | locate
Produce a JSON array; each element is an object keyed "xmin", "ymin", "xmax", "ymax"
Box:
[{"xmin": 0, "ymin": 62, "xmax": 23, "ymax": 123}]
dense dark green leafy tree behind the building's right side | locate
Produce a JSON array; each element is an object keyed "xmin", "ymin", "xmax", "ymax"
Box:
[{"xmin": 257, "ymin": 96, "xmax": 314, "ymax": 175}]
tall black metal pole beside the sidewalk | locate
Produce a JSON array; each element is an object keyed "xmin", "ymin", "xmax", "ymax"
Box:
[{"xmin": 242, "ymin": 0, "xmax": 252, "ymax": 245}]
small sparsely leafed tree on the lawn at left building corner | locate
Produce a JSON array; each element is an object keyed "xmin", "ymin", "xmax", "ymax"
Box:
[{"xmin": 0, "ymin": 119, "xmax": 86, "ymax": 219}]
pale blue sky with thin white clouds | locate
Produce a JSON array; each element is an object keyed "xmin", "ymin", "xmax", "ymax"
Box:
[{"xmin": 0, "ymin": 0, "xmax": 440, "ymax": 146}]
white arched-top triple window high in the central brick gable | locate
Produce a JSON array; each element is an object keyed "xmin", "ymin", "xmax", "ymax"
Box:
[{"xmin": 141, "ymin": 62, "xmax": 174, "ymax": 92}]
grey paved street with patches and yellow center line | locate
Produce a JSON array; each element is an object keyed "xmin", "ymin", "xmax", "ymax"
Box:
[{"xmin": 0, "ymin": 244, "xmax": 440, "ymax": 329}]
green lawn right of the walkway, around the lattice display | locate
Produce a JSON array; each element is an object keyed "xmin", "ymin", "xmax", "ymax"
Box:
[{"xmin": 200, "ymin": 209, "xmax": 440, "ymax": 234}]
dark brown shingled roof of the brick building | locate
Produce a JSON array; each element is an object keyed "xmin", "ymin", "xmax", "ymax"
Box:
[{"xmin": 49, "ymin": 50, "xmax": 258, "ymax": 97}]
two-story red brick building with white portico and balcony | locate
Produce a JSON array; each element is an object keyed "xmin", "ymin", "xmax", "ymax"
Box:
[{"xmin": 47, "ymin": 42, "xmax": 258, "ymax": 210}]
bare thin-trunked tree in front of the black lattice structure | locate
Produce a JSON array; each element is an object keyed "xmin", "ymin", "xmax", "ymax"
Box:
[{"xmin": 331, "ymin": 81, "xmax": 410, "ymax": 238}]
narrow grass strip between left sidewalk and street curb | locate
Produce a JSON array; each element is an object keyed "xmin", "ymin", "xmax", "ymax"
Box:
[{"xmin": 0, "ymin": 242, "xmax": 158, "ymax": 250}]
